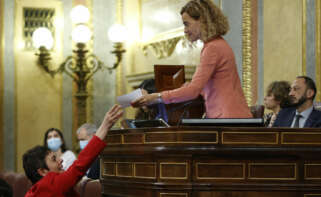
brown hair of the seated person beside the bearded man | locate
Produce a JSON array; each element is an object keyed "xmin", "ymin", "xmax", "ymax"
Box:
[{"xmin": 267, "ymin": 81, "xmax": 291, "ymax": 108}]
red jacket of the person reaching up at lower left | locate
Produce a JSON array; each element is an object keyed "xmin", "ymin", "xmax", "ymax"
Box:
[{"xmin": 25, "ymin": 136, "xmax": 106, "ymax": 197}]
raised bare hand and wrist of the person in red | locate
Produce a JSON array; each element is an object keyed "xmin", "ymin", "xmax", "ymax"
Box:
[{"xmin": 96, "ymin": 105, "xmax": 123, "ymax": 140}]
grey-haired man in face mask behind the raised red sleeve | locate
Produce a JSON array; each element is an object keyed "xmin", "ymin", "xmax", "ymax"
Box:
[{"xmin": 77, "ymin": 123, "xmax": 100, "ymax": 179}]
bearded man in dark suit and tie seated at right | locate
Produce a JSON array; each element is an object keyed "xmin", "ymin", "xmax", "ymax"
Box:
[{"xmin": 273, "ymin": 76, "xmax": 321, "ymax": 128}]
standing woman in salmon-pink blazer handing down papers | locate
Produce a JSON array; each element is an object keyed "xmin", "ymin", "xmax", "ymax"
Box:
[{"xmin": 132, "ymin": 0, "xmax": 252, "ymax": 118}]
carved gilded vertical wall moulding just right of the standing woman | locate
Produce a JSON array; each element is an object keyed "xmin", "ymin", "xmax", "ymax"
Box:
[{"xmin": 242, "ymin": 0, "xmax": 252, "ymax": 105}]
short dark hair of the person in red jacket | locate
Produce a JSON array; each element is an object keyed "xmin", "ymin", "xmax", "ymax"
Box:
[{"xmin": 22, "ymin": 145, "xmax": 51, "ymax": 184}]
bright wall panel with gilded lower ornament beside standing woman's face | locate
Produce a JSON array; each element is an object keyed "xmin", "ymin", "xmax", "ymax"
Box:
[{"xmin": 141, "ymin": 0, "xmax": 187, "ymax": 59}]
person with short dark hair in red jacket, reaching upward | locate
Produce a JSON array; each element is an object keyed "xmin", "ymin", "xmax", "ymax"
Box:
[{"xmin": 23, "ymin": 105, "xmax": 123, "ymax": 197}]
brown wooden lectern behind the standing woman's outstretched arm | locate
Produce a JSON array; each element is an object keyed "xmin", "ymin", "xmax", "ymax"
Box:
[{"xmin": 154, "ymin": 65, "xmax": 205, "ymax": 126}]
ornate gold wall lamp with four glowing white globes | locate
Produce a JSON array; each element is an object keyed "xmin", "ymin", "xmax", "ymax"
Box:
[{"xmin": 32, "ymin": 5, "xmax": 127, "ymax": 125}]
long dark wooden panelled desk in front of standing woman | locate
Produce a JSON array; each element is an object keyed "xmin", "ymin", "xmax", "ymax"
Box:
[{"xmin": 101, "ymin": 127, "xmax": 321, "ymax": 197}]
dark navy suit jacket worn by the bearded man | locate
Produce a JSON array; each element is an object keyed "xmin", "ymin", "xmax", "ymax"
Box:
[{"xmin": 273, "ymin": 107, "xmax": 321, "ymax": 128}]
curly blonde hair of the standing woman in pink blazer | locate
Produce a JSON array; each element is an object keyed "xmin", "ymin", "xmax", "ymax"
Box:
[{"xmin": 180, "ymin": 0, "xmax": 230, "ymax": 42}]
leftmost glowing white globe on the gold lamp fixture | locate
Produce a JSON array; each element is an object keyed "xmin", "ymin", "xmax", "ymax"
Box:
[{"xmin": 32, "ymin": 27, "xmax": 53, "ymax": 50}]
